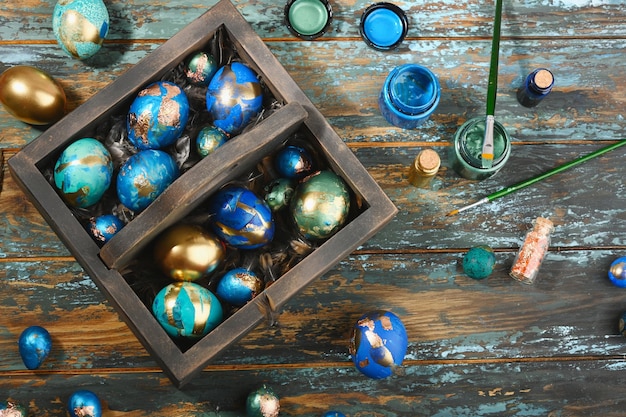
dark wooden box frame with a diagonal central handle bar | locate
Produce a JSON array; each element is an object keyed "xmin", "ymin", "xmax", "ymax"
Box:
[{"xmin": 8, "ymin": 0, "xmax": 397, "ymax": 387}]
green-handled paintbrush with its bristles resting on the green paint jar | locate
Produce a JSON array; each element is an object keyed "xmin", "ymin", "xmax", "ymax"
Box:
[{"xmin": 482, "ymin": 0, "xmax": 502, "ymax": 168}]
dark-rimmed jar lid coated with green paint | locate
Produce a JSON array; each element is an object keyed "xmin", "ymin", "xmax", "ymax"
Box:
[{"xmin": 285, "ymin": 0, "xmax": 333, "ymax": 40}]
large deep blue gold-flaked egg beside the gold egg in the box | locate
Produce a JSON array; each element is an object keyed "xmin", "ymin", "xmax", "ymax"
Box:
[{"xmin": 208, "ymin": 186, "xmax": 274, "ymax": 249}]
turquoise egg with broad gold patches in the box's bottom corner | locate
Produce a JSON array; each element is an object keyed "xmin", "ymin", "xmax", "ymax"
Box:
[{"xmin": 152, "ymin": 282, "xmax": 223, "ymax": 339}]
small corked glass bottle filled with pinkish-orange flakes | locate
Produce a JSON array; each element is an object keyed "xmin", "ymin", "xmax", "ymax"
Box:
[{"xmin": 509, "ymin": 217, "xmax": 554, "ymax": 284}]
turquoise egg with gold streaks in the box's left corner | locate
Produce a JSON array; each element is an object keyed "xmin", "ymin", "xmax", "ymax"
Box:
[{"xmin": 54, "ymin": 138, "xmax": 113, "ymax": 208}]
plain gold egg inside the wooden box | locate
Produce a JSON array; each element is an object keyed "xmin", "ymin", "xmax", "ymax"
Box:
[{"xmin": 153, "ymin": 224, "xmax": 225, "ymax": 281}]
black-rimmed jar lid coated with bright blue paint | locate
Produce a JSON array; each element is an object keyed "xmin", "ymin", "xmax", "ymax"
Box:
[{"xmin": 359, "ymin": 2, "xmax": 409, "ymax": 51}]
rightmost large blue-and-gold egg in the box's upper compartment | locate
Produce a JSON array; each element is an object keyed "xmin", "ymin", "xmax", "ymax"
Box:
[{"xmin": 206, "ymin": 62, "xmax": 263, "ymax": 135}]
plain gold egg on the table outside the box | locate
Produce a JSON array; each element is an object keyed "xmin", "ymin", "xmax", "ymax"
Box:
[{"xmin": 0, "ymin": 65, "xmax": 66, "ymax": 125}]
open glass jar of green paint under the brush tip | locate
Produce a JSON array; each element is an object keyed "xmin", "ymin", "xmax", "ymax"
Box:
[{"xmin": 449, "ymin": 116, "xmax": 511, "ymax": 180}]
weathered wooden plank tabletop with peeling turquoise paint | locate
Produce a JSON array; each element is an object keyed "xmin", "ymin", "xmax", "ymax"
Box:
[{"xmin": 0, "ymin": 0, "xmax": 626, "ymax": 417}]
